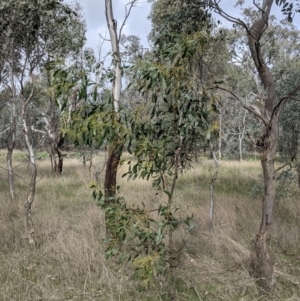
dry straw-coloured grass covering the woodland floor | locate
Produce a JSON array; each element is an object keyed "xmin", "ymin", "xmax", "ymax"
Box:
[{"xmin": 0, "ymin": 153, "xmax": 300, "ymax": 301}]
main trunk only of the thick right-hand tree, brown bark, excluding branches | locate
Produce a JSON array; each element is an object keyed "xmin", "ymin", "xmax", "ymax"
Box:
[{"xmin": 248, "ymin": 0, "xmax": 278, "ymax": 292}]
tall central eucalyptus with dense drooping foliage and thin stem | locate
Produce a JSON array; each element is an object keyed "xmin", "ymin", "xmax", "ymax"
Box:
[{"xmin": 117, "ymin": 0, "xmax": 213, "ymax": 290}]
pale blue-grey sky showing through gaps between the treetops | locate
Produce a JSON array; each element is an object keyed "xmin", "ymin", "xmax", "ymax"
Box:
[{"xmin": 78, "ymin": 0, "xmax": 300, "ymax": 54}]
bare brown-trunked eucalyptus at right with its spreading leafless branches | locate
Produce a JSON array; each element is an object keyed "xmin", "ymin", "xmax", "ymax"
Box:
[{"xmin": 207, "ymin": 0, "xmax": 300, "ymax": 292}]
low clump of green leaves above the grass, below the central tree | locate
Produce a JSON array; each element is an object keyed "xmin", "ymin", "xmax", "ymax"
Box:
[{"xmin": 91, "ymin": 185, "xmax": 189, "ymax": 287}]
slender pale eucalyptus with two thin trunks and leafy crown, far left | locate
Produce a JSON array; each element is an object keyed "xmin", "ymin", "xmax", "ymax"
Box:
[{"xmin": 0, "ymin": 0, "xmax": 86, "ymax": 244}]
